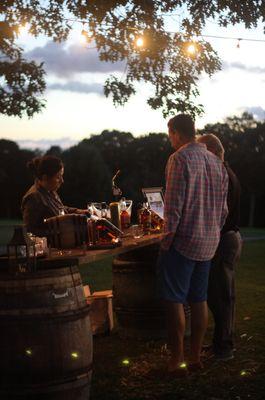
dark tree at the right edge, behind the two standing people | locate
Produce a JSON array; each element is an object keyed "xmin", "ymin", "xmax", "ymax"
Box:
[{"xmin": 202, "ymin": 113, "xmax": 265, "ymax": 226}]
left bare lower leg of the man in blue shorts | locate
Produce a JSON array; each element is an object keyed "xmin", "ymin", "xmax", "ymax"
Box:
[{"xmin": 165, "ymin": 301, "xmax": 185, "ymax": 372}]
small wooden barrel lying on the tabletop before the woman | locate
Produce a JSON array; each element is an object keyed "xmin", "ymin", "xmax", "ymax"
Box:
[{"xmin": 45, "ymin": 214, "xmax": 88, "ymax": 249}]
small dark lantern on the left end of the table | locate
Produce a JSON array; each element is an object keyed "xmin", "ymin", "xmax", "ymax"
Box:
[{"xmin": 7, "ymin": 225, "xmax": 36, "ymax": 273}]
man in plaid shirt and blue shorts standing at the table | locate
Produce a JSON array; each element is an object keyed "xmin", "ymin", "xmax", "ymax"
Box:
[{"xmin": 158, "ymin": 114, "xmax": 228, "ymax": 376}]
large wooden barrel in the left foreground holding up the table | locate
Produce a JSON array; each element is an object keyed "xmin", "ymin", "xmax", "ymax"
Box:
[{"xmin": 0, "ymin": 267, "xmax": 92, "ymax": 400}]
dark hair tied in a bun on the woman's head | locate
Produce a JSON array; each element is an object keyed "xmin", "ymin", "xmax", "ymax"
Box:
[{"xmin": 27, "ymin": 156, "xmax": 63, "ymax": 179}]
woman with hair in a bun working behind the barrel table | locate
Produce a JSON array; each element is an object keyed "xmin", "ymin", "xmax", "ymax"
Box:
[{"xmin": 21, "ymin": 156, "xmax": 87, "ymax": 236}]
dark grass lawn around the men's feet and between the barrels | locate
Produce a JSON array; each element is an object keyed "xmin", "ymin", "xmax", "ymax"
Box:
[{"xmin": 85, "ymin": 240, "xmax": 265, "ymax": 400}]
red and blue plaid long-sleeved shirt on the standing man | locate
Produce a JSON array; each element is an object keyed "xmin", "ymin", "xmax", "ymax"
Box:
[{"xmin": 162, "ymin": 142, "xmax": 228, "ymax": 261}]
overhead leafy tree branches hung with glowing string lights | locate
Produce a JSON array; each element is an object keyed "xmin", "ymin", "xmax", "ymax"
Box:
[{"xmin": 0, "ymin": 0, "xmax": 264, "ymax": 116}]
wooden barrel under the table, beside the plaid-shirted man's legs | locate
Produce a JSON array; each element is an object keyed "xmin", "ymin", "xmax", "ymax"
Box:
[{"xmin": 112, "ymin": 244, "xmax": 190, "ymax": 339}]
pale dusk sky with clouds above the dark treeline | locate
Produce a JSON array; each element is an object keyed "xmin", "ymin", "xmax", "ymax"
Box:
[{"xmin": 0, "ymin": 16, "xmax": 265, "ymax": 148}]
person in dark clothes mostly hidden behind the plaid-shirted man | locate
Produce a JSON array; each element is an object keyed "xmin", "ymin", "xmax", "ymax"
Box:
[{"xmin": 197, "ymin": 133, "xmax": 242, "ymax": 361}]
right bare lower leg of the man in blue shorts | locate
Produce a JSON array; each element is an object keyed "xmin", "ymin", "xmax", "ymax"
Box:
[{"xmin": 190, "ymin": 301, "xmax": 208, "ymax": 364}]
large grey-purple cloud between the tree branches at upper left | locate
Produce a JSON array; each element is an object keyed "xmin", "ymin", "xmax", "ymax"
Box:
[{"xmin": 25, "ymin": 41, "xmax": 125, "ymax": 78}]
